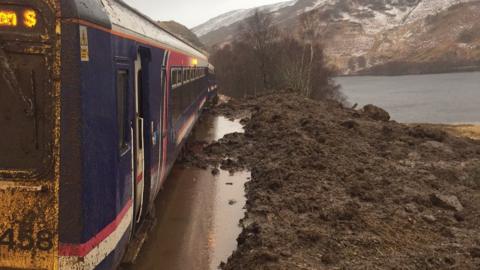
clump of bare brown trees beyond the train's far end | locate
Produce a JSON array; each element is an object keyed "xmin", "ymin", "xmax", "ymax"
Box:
[{"xmin": 211, "ymin": 11, "xmax": 342, "ymax": 102}]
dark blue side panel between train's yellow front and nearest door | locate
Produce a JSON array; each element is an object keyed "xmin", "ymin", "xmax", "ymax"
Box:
[{"xmin": 59, "ymin": 23, "xmax": 131, "ymax": 269}]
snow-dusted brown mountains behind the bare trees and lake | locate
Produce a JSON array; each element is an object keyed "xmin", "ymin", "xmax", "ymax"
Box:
[{"xmin": 192, "ymin": 0, "xmax": 480, "ymax": 74}]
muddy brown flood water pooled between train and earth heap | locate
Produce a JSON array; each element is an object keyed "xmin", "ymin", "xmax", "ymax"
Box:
[{"xmin": 125, "ymin": 116, "xmax": 250, "ymax": 270}]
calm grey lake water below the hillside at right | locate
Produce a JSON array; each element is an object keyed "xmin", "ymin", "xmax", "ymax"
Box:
[{"xmin": 336, "ymin": 72, "xmax": 480, "ymax": 124}]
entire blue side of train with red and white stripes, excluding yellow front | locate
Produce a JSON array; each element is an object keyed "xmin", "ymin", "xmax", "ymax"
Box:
[{"xmin": 54, "ymin": 2, "xmax": 209, "ymax": 270}]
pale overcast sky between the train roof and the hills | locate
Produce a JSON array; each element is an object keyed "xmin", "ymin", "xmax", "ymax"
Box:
[{"xmin": 124, "ymin": 0, "xmax": 285, "ymax": 28}]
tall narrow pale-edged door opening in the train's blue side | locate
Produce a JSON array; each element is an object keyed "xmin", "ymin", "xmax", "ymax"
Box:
[{"xmin": 133, "ymin": 53, "xmax": 145, "ymax": 223}]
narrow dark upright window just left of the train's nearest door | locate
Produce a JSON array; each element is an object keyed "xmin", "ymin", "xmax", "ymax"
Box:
[{"xmin": 117, "ymin": 70, "xmax": 128, "ymax": 150}]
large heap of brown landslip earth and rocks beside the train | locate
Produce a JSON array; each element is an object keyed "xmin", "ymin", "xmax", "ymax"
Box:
[{"xmin": 184, "ymin": 93, "xmax": 480, "ymax": 270}]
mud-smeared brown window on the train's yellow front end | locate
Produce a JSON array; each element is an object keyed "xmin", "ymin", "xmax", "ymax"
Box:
[{"xmin": 0, "ymin": 50, "xmax": 54, "ymax": 177}]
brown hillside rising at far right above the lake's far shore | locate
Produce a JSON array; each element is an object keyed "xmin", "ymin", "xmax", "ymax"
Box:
[{"xmin": 361, "ymin": 1, "xmax": 480, "ymax": 75}]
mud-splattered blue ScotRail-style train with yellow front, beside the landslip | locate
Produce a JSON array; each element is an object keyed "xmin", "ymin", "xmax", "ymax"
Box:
[{"xmin": 0, "ymin": 0, "xmax": 217, "ymax": 270}]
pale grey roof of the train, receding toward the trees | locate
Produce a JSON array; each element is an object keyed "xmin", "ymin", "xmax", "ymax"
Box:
[{"xmin": 62, "ymin": 0, "xmax": 208, "ymax": 60}]
